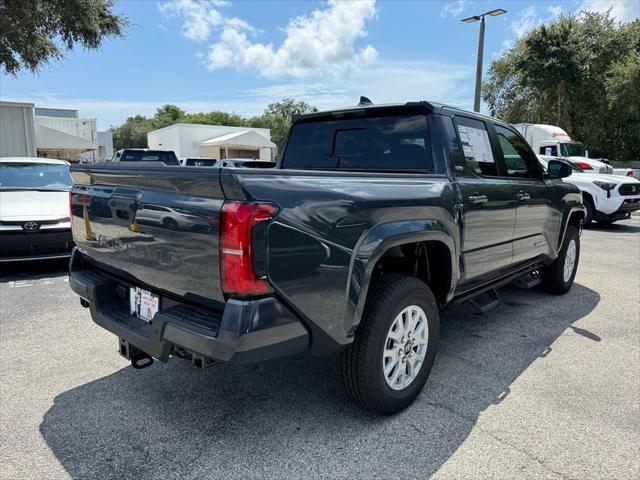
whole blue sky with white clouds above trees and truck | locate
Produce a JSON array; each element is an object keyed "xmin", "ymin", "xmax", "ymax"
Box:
[{"xmin": 0, "ymin": 0, "xmax": 640, "ymax": 129}]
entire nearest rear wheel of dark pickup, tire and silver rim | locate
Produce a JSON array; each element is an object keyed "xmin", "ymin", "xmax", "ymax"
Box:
[{"xmin": 337, "ymin": 274, "xmax": 440, "ymax": 415}]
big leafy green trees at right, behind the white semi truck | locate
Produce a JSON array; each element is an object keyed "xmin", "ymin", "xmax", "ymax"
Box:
[{"xmin": 483, "ymin": 12, "xmax": 640, "ymax": 160}]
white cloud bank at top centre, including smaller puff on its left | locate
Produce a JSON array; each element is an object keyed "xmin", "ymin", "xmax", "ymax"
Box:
[{"xmin": 158, "ymin": 0, "xmax": 378, "ymax": 78}]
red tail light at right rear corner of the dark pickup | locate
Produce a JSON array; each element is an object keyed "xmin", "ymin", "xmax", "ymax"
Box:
[{"xmin": 220, "ymin": 202, "xmax": 277, "ymax": 295}]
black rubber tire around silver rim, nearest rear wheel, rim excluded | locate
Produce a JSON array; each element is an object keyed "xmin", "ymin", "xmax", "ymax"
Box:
[{"xmin": 337, "ymin": 274, "xmax": 440, "ymax": 415}]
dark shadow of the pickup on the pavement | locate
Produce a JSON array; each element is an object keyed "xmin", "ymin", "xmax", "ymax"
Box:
[{"xmin": 40, "ymin": 285, "xmax": 600, "ymax": 479}]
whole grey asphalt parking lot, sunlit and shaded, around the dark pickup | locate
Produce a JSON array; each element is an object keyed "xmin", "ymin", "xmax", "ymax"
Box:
[{"xmin": 0, "ymin": 219, "xmax": 640, "ymax": 479}]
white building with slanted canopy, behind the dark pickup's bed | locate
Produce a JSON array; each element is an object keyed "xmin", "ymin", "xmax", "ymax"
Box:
[{"xmin": 147, "ymin": 123, "xmax": 276, "ymax": 160}]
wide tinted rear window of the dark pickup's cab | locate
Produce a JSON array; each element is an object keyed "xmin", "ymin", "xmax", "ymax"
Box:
[{"xmin": 282, "ymin": 114, "xmax": 435, "ymax": 173}]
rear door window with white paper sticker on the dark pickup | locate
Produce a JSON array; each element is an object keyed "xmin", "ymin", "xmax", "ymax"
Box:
[{"xmin": 455, "ymin": 117, "xmax": 498, "ymax": 176}]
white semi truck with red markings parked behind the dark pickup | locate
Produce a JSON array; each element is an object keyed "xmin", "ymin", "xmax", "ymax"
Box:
[{"xmin": 513, "ymin": 123, "xmax": 613, "ymax": 173}]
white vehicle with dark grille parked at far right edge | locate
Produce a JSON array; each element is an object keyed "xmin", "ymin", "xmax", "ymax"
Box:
[{"xmin": 538, "ymin": 155, "xmax": 640, "ymax": 226}]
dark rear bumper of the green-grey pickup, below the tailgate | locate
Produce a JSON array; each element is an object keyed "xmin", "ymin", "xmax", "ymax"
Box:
[{"xmin": 69, "ymin": 250, "xmax": 309, "ymax": 362}]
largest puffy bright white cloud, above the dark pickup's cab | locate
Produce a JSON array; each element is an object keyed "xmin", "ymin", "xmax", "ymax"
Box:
[{"xmin": 208, "ymin": 0, "xmax": 377, "ymax": 78}]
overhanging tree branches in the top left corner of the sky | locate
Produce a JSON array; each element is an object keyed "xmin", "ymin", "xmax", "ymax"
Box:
[{"xmin": 0, "ymin": 0, "xmax": 128, "ymax": 75}]
